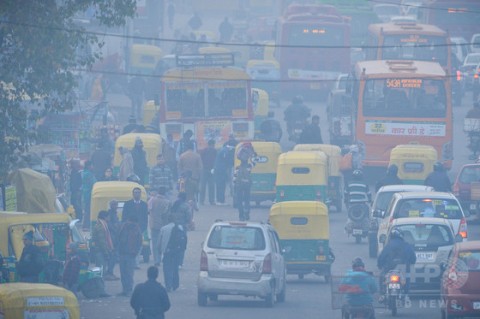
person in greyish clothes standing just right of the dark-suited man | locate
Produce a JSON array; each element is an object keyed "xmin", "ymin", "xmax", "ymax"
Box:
[{"xmin": 150, "ymin": 187, "xmax": 172, "ymax": 266}]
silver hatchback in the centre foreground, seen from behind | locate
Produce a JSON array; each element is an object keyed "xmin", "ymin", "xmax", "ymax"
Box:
[{"xmin": 197, "ymin": 222, "xmax": 287, "ymax": 307}]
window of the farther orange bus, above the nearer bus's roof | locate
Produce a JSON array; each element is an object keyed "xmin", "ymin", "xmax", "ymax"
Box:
[{"xmin": 382, "ymin": 34, "xmax": 448, "ymax": 66}]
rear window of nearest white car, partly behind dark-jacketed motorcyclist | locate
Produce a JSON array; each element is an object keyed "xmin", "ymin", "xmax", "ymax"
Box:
[{"xmin": 396, "ymin": 224, "xmax": 453, "ymax": 250}]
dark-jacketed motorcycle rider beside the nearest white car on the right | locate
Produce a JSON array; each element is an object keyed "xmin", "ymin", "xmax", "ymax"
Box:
[{"xmin": 377, "ymin": 229, "xmax": 417, "ymax": 301}]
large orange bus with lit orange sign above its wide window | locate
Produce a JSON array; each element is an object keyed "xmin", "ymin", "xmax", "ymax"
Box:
[{"xmin": 347, "ymin": 60, "xmax": 453, "ymax": 167}]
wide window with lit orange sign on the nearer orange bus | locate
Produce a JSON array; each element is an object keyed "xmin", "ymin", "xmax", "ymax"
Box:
[{"xmin": 363, "ymin": 78, "xmax": 447, "ymax": 118}]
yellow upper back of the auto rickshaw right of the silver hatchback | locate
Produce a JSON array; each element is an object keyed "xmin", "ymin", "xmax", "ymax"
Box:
[{"xmin": 270, "ymin": 201, "xmax": 330, "ymax": 240}]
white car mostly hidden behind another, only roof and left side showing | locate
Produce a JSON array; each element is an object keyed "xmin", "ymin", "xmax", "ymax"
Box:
[{"xmin": 368, "ymin": 185, "xmax": 434, "ymax": 258}]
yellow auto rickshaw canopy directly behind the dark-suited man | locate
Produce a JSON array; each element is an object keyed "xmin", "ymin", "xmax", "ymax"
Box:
[{"xmin": 90, "ymin": 181, "xmax": 147, "ymax": 222}]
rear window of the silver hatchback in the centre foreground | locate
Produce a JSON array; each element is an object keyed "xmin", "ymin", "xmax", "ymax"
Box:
[{"xmin": 208, "ymin": 225, "xmax": 265, "ymax": 250}]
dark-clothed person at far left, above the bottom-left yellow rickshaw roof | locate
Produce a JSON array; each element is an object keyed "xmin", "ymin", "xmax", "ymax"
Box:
[{"xmin": 17, "ymin": 231, "xmax": 45, "ymax": 282}]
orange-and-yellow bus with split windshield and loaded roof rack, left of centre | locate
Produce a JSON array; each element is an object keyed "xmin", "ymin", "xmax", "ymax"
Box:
[{"xmin": 158, "ymin": 53, "xmax": 254, "ymax": 148}]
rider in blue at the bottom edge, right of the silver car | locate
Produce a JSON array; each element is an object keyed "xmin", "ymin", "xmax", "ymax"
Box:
[{"xmin": 338, "ymin": 257, "xmax": 377, "ymax": 318}]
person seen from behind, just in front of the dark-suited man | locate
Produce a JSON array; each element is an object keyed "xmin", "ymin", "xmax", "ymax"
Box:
[{"xmin": 118, "ymin": 214, "xmax": 142, "ymax": 297}]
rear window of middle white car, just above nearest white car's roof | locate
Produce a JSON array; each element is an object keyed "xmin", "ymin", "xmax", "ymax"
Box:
[{"xmin": 394, "ymin": 198, "xmax": 463, "ymax": 219}]
